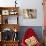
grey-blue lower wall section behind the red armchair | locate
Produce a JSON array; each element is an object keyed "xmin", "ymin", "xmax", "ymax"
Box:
[{"xmin": 19, "ymin": 26, "xmax": 43, "ymax": 43}]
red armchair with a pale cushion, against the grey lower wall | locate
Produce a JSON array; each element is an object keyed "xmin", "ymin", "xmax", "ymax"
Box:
[{"xmin": 21, "ymin": 28, "xmax": 41, "ymax": 46}]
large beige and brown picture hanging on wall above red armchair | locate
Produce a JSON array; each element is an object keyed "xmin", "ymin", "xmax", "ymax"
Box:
[{"xmin": 23, "ymin": 9, "xmax": 37, "ymax": 19}]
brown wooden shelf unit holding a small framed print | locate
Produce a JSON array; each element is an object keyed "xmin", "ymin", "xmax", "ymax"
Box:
[{"xmin": 0, "ymin": 7, "xmax": 19, "ymax": 46}]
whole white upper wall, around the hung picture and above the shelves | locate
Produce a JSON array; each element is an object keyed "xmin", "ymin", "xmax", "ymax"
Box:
[{"xmin": 0, "ymin": 0, "xmax": 43, "ymax": 26}]
